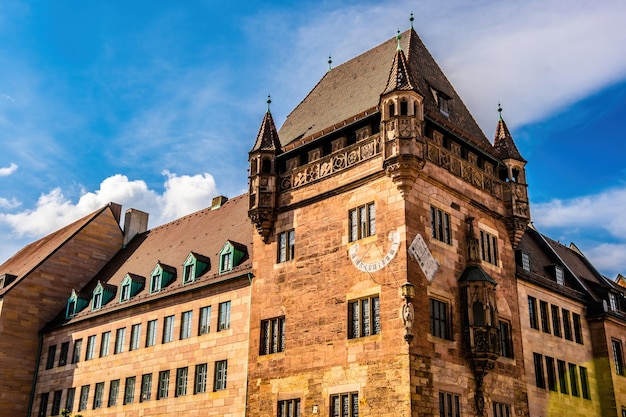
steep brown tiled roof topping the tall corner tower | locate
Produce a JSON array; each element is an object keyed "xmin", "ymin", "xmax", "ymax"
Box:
[{"xmin": 278, "ymin": 29, "xmax": 493, "ymax": 153}]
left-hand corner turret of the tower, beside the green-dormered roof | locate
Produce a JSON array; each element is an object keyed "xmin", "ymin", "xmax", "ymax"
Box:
[{"xmin": 248, "ymin": 96, "xmax": 282, "ymax": 242}]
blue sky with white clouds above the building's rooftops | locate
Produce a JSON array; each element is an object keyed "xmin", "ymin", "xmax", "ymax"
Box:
[{"xmin": 0, "ymin": 0, "xmax": 626, "ymax": 278}]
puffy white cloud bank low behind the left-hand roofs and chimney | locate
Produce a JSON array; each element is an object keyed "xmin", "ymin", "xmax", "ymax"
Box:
[{"xmin": 0, "ymin": 171, "xmax": 217, "ymax": 239}]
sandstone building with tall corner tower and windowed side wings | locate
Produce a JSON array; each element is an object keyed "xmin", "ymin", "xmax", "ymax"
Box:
[{"xmin": 0, "ymin": 23, "xmax": 626, "ymax": 417}]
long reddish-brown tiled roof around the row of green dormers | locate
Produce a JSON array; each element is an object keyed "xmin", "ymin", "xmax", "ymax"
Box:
[{"xmin": 53, "ymin": 194, "xmax": 253, "ymax": 325}]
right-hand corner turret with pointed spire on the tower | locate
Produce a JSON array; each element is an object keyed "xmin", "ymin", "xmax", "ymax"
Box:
[{"xmin": 493, "ymin": 104, "xmax": 530, "ymax": 249}]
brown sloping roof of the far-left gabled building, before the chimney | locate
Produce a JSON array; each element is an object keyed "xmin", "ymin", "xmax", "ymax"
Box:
[{"xmin": 0, "ymin": 205, "xmax": 117, "ymax": 296}]
